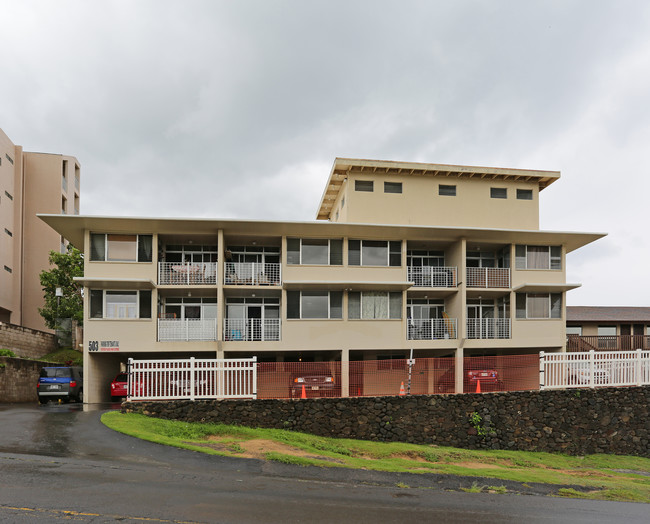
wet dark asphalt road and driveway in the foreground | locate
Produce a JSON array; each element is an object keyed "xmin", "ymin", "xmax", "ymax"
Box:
[{"xmin": 0, "ymin": 404, "xmax": 650, "ymax": 524}]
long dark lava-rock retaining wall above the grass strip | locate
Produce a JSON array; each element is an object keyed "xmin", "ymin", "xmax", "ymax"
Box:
[{"xmin": 122, "ymin": 386, "xmax": 650, "ymax": 456}]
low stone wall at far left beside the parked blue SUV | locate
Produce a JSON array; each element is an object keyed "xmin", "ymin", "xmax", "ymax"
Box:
[{"xmin": 0, "ymin": 357, "xmax": 52, "ymax": 402}]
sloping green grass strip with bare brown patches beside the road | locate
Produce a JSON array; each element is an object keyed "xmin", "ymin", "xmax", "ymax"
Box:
[{"xmin": 102, "ymin": 411, "xmax": 650, "ymax": 503}]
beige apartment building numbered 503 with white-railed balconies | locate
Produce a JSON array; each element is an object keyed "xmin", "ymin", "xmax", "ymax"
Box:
[{"xmin": 41, "ymin": 159, "xmax": 604, "ymax": 402}]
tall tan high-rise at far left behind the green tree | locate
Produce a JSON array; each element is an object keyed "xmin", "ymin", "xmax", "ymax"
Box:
[{"xmin": 0, "ymin": 129, "xmax": 80, "ymax": 331}]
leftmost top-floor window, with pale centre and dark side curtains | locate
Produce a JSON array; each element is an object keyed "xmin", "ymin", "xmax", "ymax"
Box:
[{"xmin": 90, "ymin": 233, "xmax": 153, "ymax": 262}]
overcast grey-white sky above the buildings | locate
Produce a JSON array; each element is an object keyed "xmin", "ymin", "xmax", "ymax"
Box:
[{"xmin": 0, "ymin": 0, "xmax": 650, "ymax": 306}]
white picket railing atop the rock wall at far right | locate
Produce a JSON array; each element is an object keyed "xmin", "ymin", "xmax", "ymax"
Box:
[{"xmin": 539, "ymin": 349, "xmax": 650, "ymax": 389}]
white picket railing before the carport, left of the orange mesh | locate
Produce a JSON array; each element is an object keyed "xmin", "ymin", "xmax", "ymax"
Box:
[{"xmin": 127, "ymin": 357, "xmax": 257, "ymax": 400}]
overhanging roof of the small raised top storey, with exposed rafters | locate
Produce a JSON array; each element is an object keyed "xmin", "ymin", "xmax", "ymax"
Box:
[{"xmin": 316, "ymin": 158, "xmax": 560, "ymax": 220}]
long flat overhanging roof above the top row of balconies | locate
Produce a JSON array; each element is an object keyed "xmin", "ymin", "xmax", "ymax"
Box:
[{"xmin": 37, "ymin": 214, "xmax": 607, "ymax": 253}]
